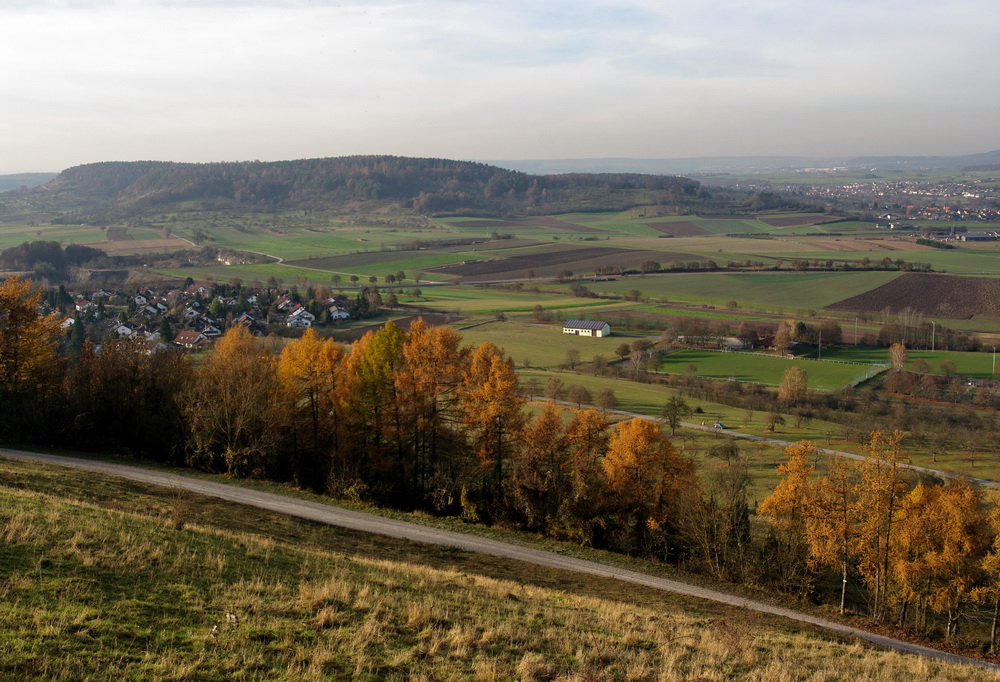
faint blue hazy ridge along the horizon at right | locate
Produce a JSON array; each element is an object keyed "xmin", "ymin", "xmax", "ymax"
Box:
[{"xmin": 488, "ymin": 150, "xmax": 1000, "ymax": 175}]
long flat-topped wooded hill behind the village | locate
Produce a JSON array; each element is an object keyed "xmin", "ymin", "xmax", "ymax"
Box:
[{"xmin": 0, "ymin": 156, "xmax": 699, "ymax": 222}]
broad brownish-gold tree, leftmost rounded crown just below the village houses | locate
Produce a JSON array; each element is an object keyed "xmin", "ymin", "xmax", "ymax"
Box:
[{"xmin": 185, "ymin": 326, "xmax": 285, "ymax": 477}]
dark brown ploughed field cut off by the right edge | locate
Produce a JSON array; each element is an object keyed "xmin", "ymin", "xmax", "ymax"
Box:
[{"xmin": 827, "ymin": 272, "xmax": 1000, "ymax": 320}]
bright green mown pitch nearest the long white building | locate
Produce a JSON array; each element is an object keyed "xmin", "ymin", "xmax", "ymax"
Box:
[{"xmin": 660, "ymin": 349, "xmax": 874, "ymax": 391}]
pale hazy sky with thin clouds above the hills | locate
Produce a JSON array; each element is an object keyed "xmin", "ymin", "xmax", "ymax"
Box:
[{"xmin": 0, "ymin": 0, "xmax": 1000, "ymax": 173}]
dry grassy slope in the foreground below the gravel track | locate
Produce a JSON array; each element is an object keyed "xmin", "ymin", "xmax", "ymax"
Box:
[{"xmin": 0, "ymin": 452, "xmax": 991, "ymax": 680}]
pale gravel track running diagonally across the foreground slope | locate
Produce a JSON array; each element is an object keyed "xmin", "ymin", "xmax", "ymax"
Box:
[{"xmin": 0, "ymin": 448, "xmax": 1000, "ymax": 671}]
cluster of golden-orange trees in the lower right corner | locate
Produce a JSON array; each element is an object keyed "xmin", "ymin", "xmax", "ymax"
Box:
[{"xmin": 758, "ymin": 431, "xmax": 1000, "ymax": 651}]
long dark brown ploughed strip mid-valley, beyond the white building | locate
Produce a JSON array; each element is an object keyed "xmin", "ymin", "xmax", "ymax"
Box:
[{"xmin": 428, "ymin": 246, "xmax": 696, "ymax": 282}]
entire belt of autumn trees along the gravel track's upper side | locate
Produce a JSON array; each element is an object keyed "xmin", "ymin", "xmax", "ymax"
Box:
[{"xmin": 0, "ymin": 277, "xmax": 1000, "ymax": 647}]
